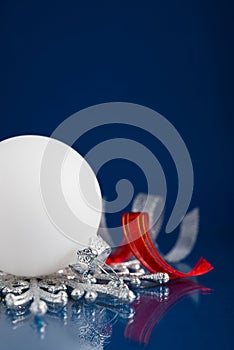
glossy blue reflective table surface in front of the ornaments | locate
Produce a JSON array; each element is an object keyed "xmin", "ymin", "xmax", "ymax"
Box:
[{"xmin": 0, "ymin": 238, "xmax": 233, "ymax": 350}]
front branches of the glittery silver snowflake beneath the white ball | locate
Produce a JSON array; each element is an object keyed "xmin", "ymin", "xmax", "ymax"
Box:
[{"xmin": 0, "ymin": 268, "xmax": 135, "ymax": 316}]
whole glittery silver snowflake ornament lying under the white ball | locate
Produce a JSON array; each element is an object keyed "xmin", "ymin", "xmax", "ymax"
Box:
[{"xmin": 0, "ymin": 261, "xmax": 169, "ymax": 316}]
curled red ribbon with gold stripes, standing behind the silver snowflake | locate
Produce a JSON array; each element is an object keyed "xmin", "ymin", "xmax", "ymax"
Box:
[{"xmin": 107, "ymin": 213, "xmax": 213, "ymax": 279}]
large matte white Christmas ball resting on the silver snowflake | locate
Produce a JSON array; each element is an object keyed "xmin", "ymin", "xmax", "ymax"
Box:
[{"xmin": 0, "ymin": 135, "xmax": 102, "ymax": 276}]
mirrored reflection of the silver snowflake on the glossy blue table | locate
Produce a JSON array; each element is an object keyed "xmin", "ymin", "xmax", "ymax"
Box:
[{"xmin": 0, "ymin": 286, "xmax": 135, "ymax": 349}]
